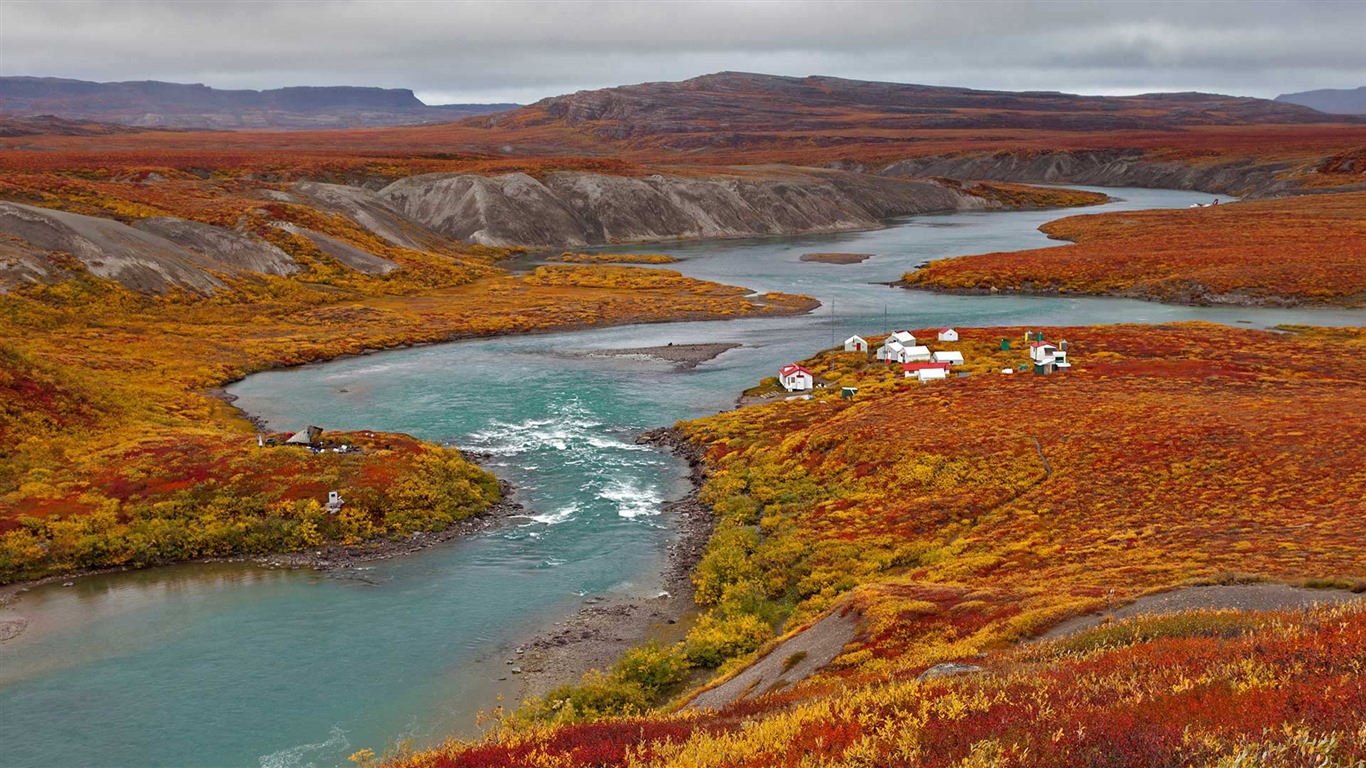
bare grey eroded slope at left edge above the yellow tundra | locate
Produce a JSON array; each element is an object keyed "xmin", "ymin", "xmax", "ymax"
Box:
[{"xmin": 0, "ymin": 202, "xmax": 310, "ymax": 294}]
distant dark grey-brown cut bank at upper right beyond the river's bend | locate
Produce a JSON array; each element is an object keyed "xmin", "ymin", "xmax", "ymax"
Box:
[{"xmin": 878, "ymin": 149, "xmax": 1343, "ymax": 197}]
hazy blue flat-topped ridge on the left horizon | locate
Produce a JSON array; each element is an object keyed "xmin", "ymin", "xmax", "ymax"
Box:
[{"xmin": 0, "ymin": 77, "xmax": 516, "ymax": 130}]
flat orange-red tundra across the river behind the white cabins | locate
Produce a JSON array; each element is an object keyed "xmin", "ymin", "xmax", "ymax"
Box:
[{"xmin": 906, "ymin": 193, "xmax": 1366, "ymax": 307}]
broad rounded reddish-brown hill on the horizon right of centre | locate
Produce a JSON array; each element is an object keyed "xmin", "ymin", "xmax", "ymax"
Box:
[{"xmin": 467, "ymin": 72, "xmax": 1332, "ymax": 149}]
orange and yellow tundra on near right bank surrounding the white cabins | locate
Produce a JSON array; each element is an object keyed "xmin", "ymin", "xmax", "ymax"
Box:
[{"xmin": 398, "ymin": 323, "xmax": 1366, "ymax": 767}]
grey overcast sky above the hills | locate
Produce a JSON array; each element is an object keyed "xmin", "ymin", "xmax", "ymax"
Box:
[{"xmin": 0, "ymin": 0, "xmax": 1366, "ymax": 104}]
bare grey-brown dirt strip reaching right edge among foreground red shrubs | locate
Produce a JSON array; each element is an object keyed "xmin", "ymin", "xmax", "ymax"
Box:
[{"xmin": 1034, "ymin": 584, "xmax": 1366, "ymax": 642}]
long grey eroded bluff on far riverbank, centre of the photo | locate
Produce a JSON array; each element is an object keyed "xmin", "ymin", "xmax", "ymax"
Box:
[{"xmin": 378, "ymin": 167, "xmax": 994, "ymax": 247}]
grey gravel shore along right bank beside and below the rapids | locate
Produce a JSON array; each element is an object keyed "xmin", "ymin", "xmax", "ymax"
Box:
[{"xmin": 502, "ymin": 426, "xmax": 714, "ymax": 708}]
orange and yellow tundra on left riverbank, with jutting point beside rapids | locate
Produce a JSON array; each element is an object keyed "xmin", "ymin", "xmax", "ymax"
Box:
[{"xmin": 0, "ymin": 157, "xmax": 810, "ymax": 582}]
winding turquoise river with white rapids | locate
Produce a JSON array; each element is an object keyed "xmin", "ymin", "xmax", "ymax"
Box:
[{"xmin": 0, "ymin": 190, "xmax": 1366, "ymax": 767}]
